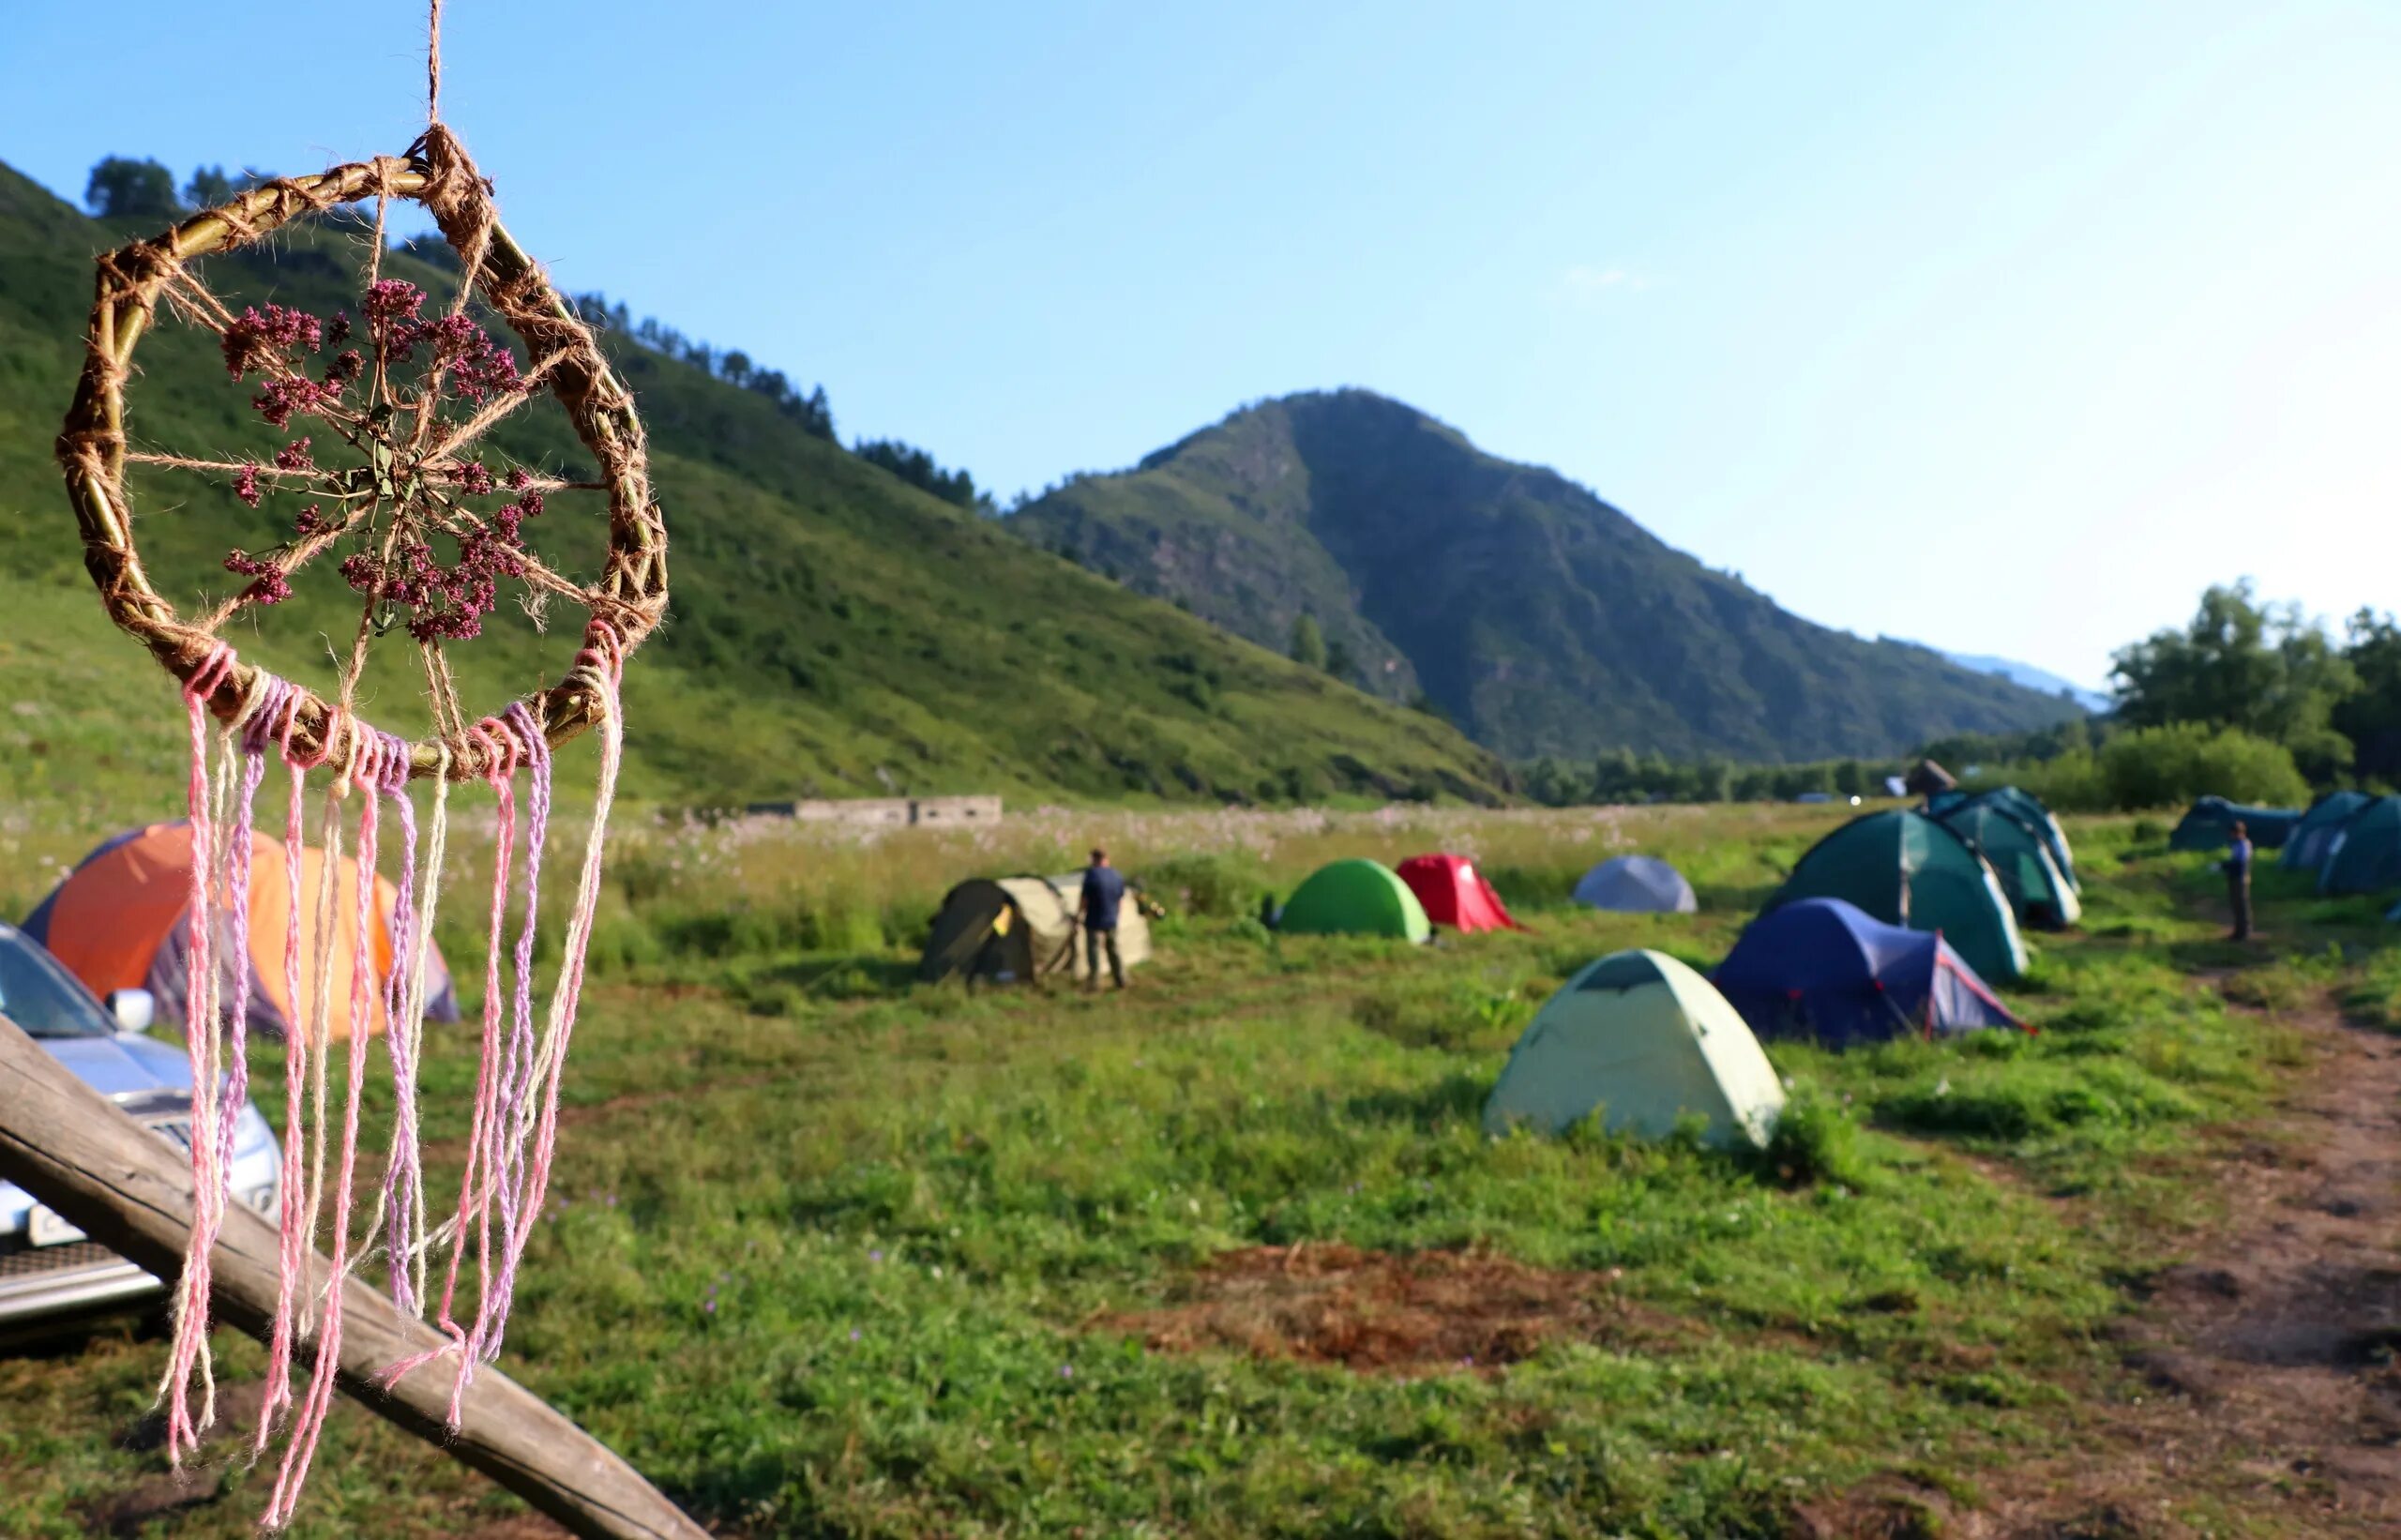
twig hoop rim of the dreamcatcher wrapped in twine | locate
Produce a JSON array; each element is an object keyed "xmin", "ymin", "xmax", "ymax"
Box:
[{"xmin": 57, "ymin": 123, "xmax": 668, "ymax": 781}]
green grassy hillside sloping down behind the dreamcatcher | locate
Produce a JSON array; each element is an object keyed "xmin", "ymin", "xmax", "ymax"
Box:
[{"xmin": 0, "ymin": 166, "xmax": 1508, "ymax": 812}]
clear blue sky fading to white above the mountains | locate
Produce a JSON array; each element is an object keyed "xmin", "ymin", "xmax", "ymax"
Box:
[{"xmin": 0, "ymin": 0, "xmax": 2401, "ymax": 683}]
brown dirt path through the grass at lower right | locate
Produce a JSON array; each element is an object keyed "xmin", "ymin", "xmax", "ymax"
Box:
[{"xmin": 1945, "ymin": 1009, "xmax": 2401, "ymax": 1540}]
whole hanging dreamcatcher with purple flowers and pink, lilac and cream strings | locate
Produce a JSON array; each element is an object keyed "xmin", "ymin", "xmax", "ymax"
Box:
[{"xmin": 57, "ymin": 0, "xmax": 668, "ymax": 1526}]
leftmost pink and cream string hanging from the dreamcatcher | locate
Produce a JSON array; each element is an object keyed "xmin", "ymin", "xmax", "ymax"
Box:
[{"xmin": 159, "ymin": 642, "xmax": 233, "ymax": 1468}]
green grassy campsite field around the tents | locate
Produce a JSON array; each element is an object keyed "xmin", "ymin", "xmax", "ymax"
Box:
[{"xmin": 0, "ymin": 808, "xmax": 2372, "ymax": 1537}]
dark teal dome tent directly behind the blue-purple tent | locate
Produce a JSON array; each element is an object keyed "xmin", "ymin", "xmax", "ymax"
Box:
[{"xmin": 1770, "ymin": 809, "xmax": 2027, "ymax": 983}]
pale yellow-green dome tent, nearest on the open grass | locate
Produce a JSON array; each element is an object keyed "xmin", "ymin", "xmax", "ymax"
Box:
[{"xmin": 1484, "ymin": 951, "xmax": 1784, "ymax": 1146}]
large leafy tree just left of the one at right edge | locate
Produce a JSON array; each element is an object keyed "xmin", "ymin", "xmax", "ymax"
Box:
[{"xmin": 2110, "ymin": 579, "xmax": 2360, "ymax": 781}]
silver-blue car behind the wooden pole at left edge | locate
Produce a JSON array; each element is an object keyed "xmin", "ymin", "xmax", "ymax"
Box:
[{"xmin": 0, "ymin": 925, "xmax": 283, "ymax": 1329}]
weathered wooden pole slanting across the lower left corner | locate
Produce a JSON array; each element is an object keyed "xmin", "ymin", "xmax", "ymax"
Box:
[{"xmin": 0, "ymin": 1017, "xmax": 708, "ymax": 1540}]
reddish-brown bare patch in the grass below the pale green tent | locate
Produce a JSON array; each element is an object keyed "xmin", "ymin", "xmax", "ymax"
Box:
[{"xmin": 1095, "ymin": 1242, "xmax": 1681, "ymax": 1374}]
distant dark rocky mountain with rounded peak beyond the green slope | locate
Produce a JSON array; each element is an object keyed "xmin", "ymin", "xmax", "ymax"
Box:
[{"xmin": 1008, "ymin": 389, "xmax": 2072, "ymax": 759}]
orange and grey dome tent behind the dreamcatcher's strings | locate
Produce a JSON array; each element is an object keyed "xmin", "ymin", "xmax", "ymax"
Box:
[{"xmin": 24, "ymin": 822, "xmax": 459, "ymax": 1040}]
